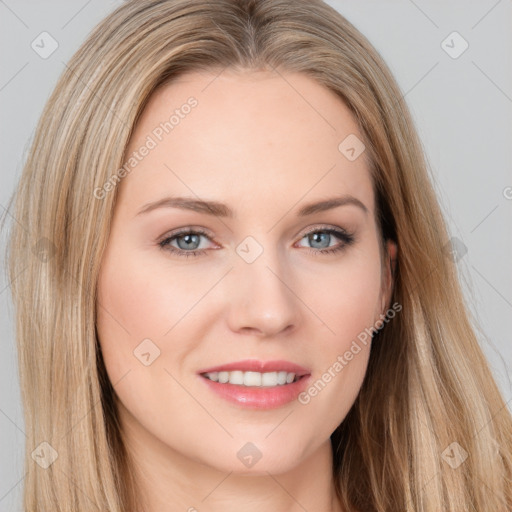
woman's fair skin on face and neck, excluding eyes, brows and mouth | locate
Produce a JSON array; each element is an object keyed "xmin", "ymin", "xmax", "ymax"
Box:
[{"xmin": 97, "ymin": 70, "xmax": 396, "ymax": 512}]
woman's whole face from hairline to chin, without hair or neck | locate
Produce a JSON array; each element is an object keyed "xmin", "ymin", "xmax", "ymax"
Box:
[{"xmin": 96, "ymin": 70, "xmax": 390, "ymax": 474}]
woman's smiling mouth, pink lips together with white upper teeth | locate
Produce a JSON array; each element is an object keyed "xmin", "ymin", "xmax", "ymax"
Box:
[{"xmin": 198, "ymin": 360, "xmax": 311, "ymax": 409}]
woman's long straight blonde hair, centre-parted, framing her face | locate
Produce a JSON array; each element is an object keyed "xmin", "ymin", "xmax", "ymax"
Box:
[{"xmin": 5, "ymin": 0, "xmax": 512, "ymax": 512}]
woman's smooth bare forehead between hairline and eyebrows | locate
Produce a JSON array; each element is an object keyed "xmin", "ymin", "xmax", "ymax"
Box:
[{"xmin": 121, "ymin": 70, "xmax": 373, "ymax": 218}]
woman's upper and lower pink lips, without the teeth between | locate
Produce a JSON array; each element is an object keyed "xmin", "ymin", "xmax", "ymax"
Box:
[{"xmin": 198, "ymin": 360, "xmax": 311, "ymax": 410}]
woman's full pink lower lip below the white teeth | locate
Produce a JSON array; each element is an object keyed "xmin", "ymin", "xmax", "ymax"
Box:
[{"xmin": 199, "ymin": 375, "xmax": 311, "ymax": 409}]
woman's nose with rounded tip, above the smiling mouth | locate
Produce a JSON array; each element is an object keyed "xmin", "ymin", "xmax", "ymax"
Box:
[{"xmin": 226, "ymin": 246, "xmax": 301, "ymax": 338}]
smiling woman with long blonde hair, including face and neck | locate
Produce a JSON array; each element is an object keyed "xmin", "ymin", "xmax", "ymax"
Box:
[{"xmin": 5, "ymin": 0, "xmax": 512, "ymax": 512}]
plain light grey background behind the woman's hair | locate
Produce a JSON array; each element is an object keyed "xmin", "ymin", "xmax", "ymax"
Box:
[{"xmin": 0, "ymin": 0, "xmax": 512, "ymax": 511}]
